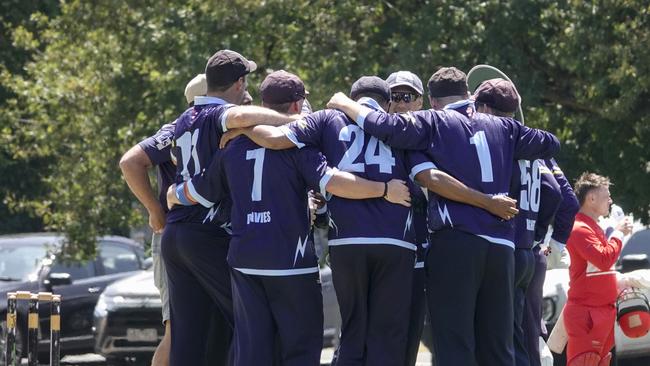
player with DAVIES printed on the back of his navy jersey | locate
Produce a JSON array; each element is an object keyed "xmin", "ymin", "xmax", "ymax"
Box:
[{"xmin": 220, "ymin": 71, "xmax": 416, "ymax": 366}]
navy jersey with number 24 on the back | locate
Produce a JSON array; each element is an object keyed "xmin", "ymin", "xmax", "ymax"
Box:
[{"xmin": 281, "ymin": 109, "xmax": 416, "ymax": 250}]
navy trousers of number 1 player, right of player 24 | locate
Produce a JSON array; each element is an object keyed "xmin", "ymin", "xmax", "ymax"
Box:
[{"xmin": 425, "ymin": 229, "xmax": 515, "ymax": 366}]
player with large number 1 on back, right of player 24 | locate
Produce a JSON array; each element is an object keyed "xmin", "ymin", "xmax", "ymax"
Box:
[{"xmin": 328, "ymin": 70, "xmax": 559, "ymax": 365}]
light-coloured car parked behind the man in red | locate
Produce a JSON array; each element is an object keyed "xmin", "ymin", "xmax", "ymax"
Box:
[{"xmin": 542, "ymin": 229, "xmax": 650, "ymax": 364}]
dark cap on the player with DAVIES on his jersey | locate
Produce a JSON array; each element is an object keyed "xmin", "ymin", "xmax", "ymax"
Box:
[{"xmin": 260, "ymin": 70, "xmax": 306, "ymax": 104}]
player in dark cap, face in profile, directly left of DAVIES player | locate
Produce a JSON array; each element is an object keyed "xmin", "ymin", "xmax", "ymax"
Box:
[{"xmin": 162, "ymin": 50, "xmax": 306, "ymax": 366}]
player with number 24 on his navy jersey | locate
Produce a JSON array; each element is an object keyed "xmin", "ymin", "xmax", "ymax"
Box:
[{"xmin": 219, "ymin": 77, "xmax": 516, "ymax": 366}]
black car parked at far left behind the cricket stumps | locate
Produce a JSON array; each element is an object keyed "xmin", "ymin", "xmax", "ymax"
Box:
[{"xmin": 0, "ymin": 233, "xmax": 149, "ymax": 365}]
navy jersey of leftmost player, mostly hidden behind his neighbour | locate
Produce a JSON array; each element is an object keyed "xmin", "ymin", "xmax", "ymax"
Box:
[{"xmin": 138, "ymin": 121, "xmax": 176, "ymax": 213}]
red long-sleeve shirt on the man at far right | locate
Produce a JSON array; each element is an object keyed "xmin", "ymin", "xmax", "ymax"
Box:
[{"xmin": 566, "ymin": 213, "xmax": 623, "ymax": 306}]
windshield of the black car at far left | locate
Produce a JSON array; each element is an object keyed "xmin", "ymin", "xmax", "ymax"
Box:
[{"xmin": 0, "ymin": 245, "xmax": 47, "ymax": 281}]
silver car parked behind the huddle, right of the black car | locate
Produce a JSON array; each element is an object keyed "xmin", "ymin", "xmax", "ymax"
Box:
[{"xmin": 94, "ymin": 266, "xmax": 341, "ymax": 363}]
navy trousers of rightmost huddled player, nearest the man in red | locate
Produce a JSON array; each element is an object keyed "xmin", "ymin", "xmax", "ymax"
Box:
[{"xmin": 522, "ymin": 246, "xmax": 546, "ymax": 366}]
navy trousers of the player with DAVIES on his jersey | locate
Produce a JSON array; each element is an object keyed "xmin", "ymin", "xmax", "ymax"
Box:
[{"xmin": 231, "ymin": 269, "xmax": 323, "ymax": 366}]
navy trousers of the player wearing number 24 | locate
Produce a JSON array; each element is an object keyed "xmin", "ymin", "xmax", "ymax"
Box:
[{"xmin": 329, "ymin": 244, "xmax": 415, "ymax": 366}]
